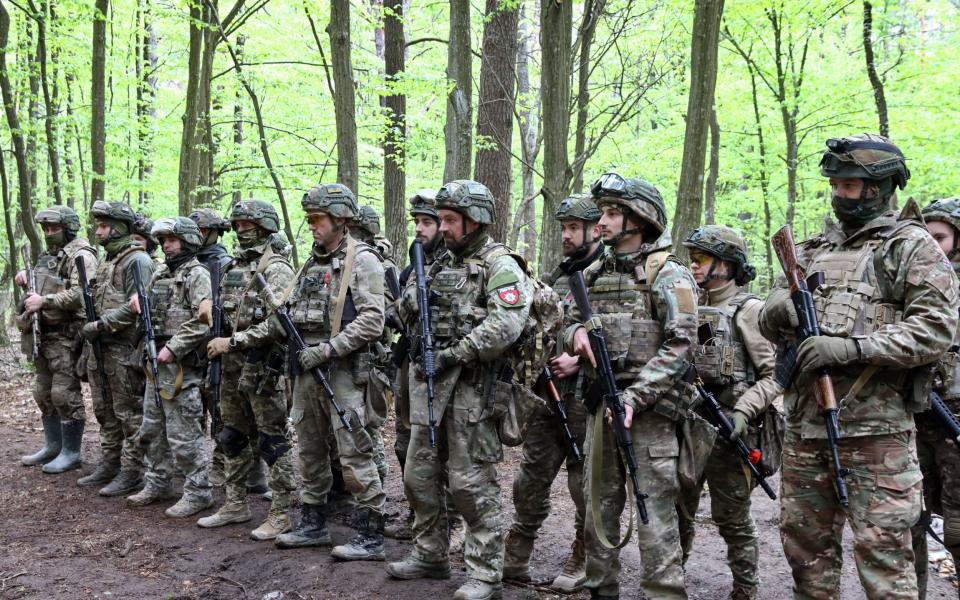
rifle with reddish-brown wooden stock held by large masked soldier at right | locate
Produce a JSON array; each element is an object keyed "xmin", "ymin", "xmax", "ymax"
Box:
[{"xmin": 770, "ymin": 225, "xmax": 850, "ymax": 506}]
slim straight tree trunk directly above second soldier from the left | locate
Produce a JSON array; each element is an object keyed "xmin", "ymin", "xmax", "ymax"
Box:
[{"xmin": 90, "ymin": 0, "xmax": 110, "ymax": 202}]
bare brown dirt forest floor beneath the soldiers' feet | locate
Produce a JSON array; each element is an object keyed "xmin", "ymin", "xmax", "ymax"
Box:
[{"xmin": 0, "ymin": 345, "xmax": 957, "ymax": 600}]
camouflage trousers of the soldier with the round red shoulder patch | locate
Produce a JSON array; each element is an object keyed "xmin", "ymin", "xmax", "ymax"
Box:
[{"xmin": 403, "ymin": 396, "xmax": 504, "ymax": 583}]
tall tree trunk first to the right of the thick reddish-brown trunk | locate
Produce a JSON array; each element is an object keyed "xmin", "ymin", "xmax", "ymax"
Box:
[{"xmin": 540, "ymin": 2, "xmax": 573, "ymax": 272}]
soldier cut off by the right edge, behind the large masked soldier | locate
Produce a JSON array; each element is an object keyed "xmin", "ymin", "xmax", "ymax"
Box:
[{"xmin": 911, "ymin": 198, "xmax": 960, "ymax": 599}]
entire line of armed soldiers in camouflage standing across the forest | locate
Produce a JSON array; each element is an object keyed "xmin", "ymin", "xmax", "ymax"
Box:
[{"xmin": 11, "ymin": 134, "xmax": 960, "ymax": 599}]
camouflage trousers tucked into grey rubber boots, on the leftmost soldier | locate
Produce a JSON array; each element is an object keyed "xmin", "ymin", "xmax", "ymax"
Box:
[{"xmin": 33, "ymin": 334, "xmax": 86, "ymax": 421}]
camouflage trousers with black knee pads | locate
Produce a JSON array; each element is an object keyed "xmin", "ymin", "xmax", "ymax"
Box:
[{"xmin": 220, "ymin": 357, "xmax": 296, "ymax": 508}]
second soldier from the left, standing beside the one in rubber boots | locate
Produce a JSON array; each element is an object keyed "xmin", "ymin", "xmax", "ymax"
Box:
[{"xmin": 77, "ymin": 201, "xmax": 155, "ymax": 496}]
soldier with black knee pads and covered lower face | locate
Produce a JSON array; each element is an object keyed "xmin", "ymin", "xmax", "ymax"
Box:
[{"xmin": 197, "ymin": 200, "xmax": 295, "ymax": 540}]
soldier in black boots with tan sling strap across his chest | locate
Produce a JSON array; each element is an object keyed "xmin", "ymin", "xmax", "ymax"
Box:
[{"xmin": 208, "ymin": 184, "xmax": 385, "ymax": 560}]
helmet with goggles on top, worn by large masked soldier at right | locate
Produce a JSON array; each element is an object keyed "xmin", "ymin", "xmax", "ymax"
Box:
[{"xmin": 820, "ymin": 133, "xmax": 910, "ymax": 190}]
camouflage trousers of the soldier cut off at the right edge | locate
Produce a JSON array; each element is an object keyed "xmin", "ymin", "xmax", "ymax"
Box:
[{"xmin": 911, "ymin": 407, "xmax": 960, "ymax": 600}]
